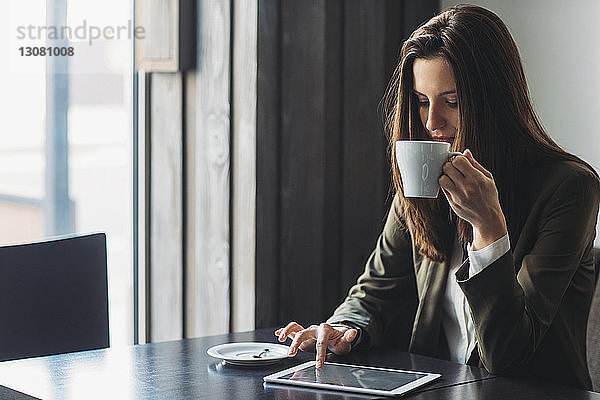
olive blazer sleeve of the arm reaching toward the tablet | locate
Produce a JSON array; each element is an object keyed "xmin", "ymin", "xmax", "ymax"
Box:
[{"xmin": 327, "ymin": 196, "xmax": 417, "ymax": 346}]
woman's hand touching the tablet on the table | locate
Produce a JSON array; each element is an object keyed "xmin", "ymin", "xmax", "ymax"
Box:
[{"xmin": 275, "ymin": 322, "xmax": 358, "ymax": 369}]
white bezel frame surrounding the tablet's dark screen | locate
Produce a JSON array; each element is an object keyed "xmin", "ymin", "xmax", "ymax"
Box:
[{"xmin": 263, "ymin": 361, "xmax": 442, "ymax": 396}]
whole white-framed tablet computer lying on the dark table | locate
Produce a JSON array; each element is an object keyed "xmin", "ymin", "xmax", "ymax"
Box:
[{"xmin": 264, "ymin": 361, "xmax": 441, "ymax": 396}]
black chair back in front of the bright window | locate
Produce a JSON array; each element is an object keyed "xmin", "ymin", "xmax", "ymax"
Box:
[{"xmin": 0, "ymin": 233, "xmax": 109, "ymax": 361}]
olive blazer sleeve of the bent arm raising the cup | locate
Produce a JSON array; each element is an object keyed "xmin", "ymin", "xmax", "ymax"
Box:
[{"xmin": 456, "ymin": 170, "xmax": 600, "ymax": 373}]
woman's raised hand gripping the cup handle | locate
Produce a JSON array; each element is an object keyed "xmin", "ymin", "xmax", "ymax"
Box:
[{"xmin": 439, "ymin": 150, "xmax": 506, "ymax": 250}]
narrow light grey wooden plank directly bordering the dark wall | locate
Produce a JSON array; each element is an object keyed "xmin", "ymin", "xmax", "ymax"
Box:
[{"xmin": 231, "ymin": 0, "xmax": 257, "ymax": 332}]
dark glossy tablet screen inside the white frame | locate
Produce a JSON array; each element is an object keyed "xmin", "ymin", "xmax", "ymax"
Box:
[{"xmin": 279, "ymin": 363, "xmax": 427, "ymax": 391}]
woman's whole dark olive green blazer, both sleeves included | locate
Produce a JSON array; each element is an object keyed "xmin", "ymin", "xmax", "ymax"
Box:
[{"xmin": 328, "ymin": 161, "xmax": 600, "ymax": 389}]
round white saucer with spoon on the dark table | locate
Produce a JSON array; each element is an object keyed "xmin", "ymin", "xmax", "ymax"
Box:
[{"xmin": 206, "ymin": 342, "xmax": 290, "ymax": 366}]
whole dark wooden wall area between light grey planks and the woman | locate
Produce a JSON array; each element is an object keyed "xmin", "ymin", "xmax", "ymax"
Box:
[{"xmin": 256, "ymin": 0, "xmax": 437, "ymax": 327}]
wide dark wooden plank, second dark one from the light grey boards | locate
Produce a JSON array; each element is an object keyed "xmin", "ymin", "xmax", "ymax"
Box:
[{"xmin": 279, "ymin": 0, "xmax": 342, "ymax": 323}]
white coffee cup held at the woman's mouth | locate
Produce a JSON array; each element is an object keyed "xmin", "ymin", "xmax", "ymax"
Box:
[{"xmin": 396, "ymin": 140, "xmax": 462, "ymax": 199}]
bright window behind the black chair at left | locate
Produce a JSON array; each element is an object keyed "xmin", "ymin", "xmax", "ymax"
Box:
[{"xmin": 0, "ymin": 0, "xmax": 134, "ymax": 345}]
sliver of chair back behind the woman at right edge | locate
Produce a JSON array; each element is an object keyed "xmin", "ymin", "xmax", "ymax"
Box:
[{"xmin": 587, "ymin": 249, "xmax": 600, "ymax": 392}]
